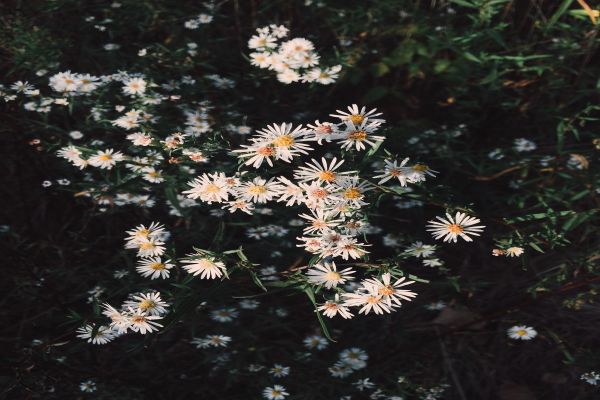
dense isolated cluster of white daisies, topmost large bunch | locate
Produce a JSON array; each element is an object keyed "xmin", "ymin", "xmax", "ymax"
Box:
[{"xmin": 248, "ymin": 25, "xmax": 342, "ymax": 85}]
